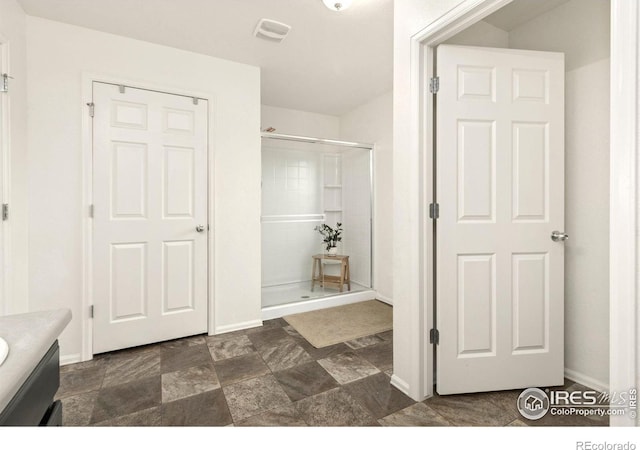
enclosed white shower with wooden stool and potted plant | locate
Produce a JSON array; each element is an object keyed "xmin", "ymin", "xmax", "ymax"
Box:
[{"xmin": 261, "ymin": 133, "xmax": 374, "ymax": 319}]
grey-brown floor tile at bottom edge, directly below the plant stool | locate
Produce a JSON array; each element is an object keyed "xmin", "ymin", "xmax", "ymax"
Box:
[{"xmin": 295, "ymin": 388, "xmax": 379, "ymax": 427}]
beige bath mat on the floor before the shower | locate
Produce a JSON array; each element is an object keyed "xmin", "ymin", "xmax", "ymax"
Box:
[{"xmin": 283, "ymin": 300, "xmax": 393, "ymax": 348}]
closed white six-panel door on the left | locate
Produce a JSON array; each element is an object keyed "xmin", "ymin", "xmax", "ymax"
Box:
[{"xmin": 92, "ymin": 82, "xmax": 208, "ymax": 353}]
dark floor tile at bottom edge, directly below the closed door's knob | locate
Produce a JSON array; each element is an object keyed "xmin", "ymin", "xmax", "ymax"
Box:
[{"xmin": 162, "ymin": 389, "xmax": 232, "ymax": 426}]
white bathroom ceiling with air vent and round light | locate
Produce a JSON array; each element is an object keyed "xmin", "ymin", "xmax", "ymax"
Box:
[{"xmin": 18, "ymin": 0, "xmax": 393, "ymax": 115}]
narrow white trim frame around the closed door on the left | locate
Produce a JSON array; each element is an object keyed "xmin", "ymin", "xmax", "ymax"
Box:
[{"xmin": 79, "ymin": 72, "xmax": 216, "ymax": 363}]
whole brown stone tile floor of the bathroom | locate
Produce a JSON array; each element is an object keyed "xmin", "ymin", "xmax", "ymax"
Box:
[{"xmin": 57, "ymin": 319, "xmax": 608, "ymax": 426}]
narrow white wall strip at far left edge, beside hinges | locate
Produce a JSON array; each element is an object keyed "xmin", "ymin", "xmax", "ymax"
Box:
[{"xmin": 0, "ymin": 0, "xmax": 29, "ymax": 314}]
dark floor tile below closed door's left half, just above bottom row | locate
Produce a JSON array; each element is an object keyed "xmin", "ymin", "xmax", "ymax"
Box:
[{"xmin": 91, "ymin": 375, "xmax": 162, "ymax": 423}]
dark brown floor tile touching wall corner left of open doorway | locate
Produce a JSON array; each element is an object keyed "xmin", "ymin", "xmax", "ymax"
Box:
[{"xmin": 343, "ymin": 373, "xmax": 415, "ymax": 419}]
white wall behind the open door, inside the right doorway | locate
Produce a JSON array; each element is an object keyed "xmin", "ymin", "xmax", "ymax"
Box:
[{"xmin": 509, "ymin": 0, "xmax": 610, "ymax": 389}]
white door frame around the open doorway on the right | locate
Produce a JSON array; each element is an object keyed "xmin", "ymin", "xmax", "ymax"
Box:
[{"xmin": 408, "ymin": 0, "xmax": 640, "ymax": 425}]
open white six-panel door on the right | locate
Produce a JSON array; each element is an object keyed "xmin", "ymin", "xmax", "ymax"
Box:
[{"xmin": 436, "ymin": 45, "xmax": 564, "ymax": 394}]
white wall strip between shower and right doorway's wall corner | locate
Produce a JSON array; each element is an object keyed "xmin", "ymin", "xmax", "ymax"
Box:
[{"xmin": 340, "ymin": 92, "xmax": 394, "ymax": 302}]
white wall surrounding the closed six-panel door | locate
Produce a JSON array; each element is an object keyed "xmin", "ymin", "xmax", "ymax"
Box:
[{"xmin": 27, "ymin": 17, "xmax": 261, "ymax": 361}]
